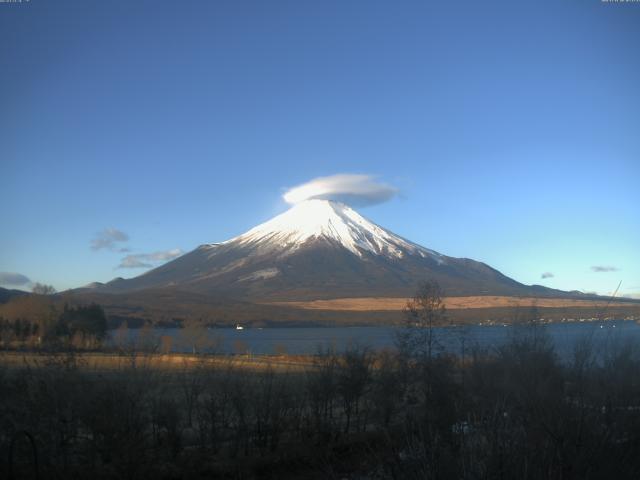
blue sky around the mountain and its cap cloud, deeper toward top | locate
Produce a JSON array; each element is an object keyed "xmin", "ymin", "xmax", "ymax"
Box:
[{"xmin": 0, "ymin": 0, "xmax": 640, "ymax": 296}]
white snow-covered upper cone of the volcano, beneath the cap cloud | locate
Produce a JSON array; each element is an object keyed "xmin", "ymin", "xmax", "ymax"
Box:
[{"xmin": 218, "ymin": 199, "xmax": 441, "ymax": 258}]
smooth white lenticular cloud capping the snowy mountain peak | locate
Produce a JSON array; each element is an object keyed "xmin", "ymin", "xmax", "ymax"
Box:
[{"xmin": 283, "ymin": 174, "xmax": 398, "ymax": 206}]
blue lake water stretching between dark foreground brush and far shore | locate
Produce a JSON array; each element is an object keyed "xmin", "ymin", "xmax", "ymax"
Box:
[{"xmin": 108, "ymin": 320, "xmax": 640, "ymax": 358}]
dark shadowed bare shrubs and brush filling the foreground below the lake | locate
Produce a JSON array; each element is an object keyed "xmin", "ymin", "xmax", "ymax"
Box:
[{"xmin": 0, "ymin": 327, "xmax": 640, "ymax": 479}]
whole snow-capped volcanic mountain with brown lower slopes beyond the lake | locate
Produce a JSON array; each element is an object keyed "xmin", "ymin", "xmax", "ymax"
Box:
[{"xmin": 92, "ymin": 199, "xmax": 567, "ymax": 302}]
